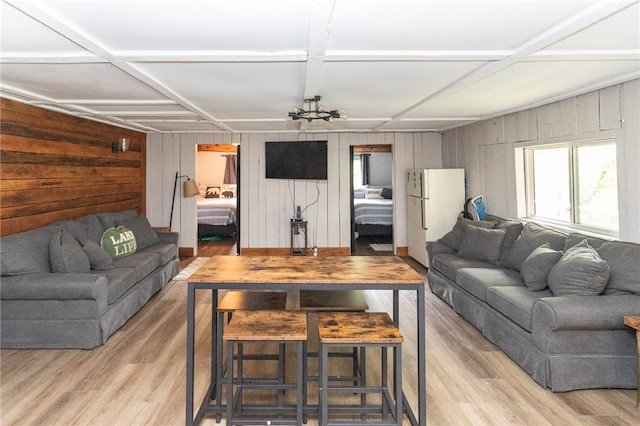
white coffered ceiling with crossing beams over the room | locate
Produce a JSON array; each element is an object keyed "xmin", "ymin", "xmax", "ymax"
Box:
[{"xmin": 0, "ymin": 0, "xmax": 640, "ymax": 132}]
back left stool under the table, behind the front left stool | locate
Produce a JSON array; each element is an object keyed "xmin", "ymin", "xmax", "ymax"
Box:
[{"xmin": 215, "ymin": 290, "xmax": 287, "ymax": 423}]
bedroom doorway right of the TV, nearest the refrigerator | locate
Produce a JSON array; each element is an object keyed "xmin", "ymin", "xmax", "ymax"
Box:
[{"xmin": 350, "ymin": 145, "xmax": 395, "ymax": 256}]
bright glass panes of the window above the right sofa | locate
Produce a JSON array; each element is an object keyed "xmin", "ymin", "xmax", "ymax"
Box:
[{"xmin": 524, "ymin": 140, "xmax": 618, "ymax": 235}]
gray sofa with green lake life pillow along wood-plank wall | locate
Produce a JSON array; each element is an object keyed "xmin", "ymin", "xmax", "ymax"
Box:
[{"xmin": 0, "ymin": 211, "xmax": 180, "ymax": 349}]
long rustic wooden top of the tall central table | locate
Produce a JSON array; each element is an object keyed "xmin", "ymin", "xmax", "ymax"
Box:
[{"xmin": 188, "ymin": 256, "xmax": 424, "ymax": 285}]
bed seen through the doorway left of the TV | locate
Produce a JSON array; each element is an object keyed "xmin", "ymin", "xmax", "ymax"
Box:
[{"xmin": 198, "ymin": 195, "xmax": 238, "ymax": 240}]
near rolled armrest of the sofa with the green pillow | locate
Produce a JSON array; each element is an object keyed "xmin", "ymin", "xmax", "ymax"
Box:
[{"xmin": 0, "ymin": 274, "xmax": 109, "ymax": 309}]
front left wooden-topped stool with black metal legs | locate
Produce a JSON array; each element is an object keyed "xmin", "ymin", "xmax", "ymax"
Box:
[{"xmin": 224, "ymin": 311, "xmax": 307, "ymax": 425}]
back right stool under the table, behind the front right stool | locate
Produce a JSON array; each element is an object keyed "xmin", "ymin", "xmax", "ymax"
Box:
[{"xmin": 300, "ymin": 290, "xmax": 369, "ymax": 384}]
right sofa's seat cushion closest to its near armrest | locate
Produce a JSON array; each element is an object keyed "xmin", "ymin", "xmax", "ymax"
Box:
[{"xmin": 487, "ymin": 286, "xmax": 553, "ymax": 332}]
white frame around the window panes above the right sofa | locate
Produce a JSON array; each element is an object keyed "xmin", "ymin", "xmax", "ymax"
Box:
[{"xmin": 516, "ymin": 132, "xmax": 620, "ymax": 238}]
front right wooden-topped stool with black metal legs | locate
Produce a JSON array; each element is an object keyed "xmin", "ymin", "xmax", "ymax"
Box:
[{"xmin": 318, "ymin": 312, "xmax": 403, "ymax": 425}]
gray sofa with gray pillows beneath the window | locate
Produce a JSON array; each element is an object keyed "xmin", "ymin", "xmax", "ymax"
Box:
[{"xmin": 427, "ymin": 215, "xmax": 640, "ymax": 392}]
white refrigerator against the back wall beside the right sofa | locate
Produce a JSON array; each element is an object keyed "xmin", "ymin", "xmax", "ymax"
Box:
[{"xmin": 406, "ymin": 169, "xmax": 465, "ymax": 267}]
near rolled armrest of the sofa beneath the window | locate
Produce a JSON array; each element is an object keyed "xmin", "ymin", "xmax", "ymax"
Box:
[{"xmin": 532, "ymin": 294, "xmax": 640, "ymax": 339}]
